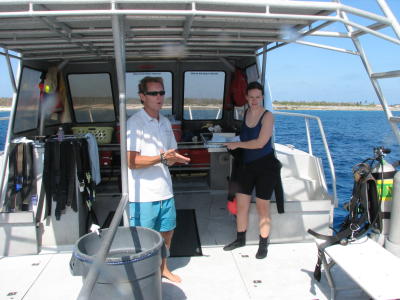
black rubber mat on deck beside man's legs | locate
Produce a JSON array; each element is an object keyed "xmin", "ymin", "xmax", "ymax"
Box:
[{"xmin": 170, "ymin": 209, "xmax": 203, "ymax": 257}]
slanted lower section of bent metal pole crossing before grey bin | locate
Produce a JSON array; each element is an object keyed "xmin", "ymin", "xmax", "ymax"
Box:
[{"xmin": 77, "ymin": 195, "xmax": 129, "ymax": 300}]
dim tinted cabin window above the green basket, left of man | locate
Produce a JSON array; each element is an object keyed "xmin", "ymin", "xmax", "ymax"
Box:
[{"xmin": 68, "ymin": 73, "xmax": 115, "ymax": 123}]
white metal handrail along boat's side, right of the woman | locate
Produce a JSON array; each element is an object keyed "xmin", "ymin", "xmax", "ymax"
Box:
[{"xmin": 274, "ymin": 111, "xmax": 338, "ymax": 207}]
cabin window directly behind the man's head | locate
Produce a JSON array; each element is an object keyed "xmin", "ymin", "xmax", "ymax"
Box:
[{"xmin": 126, "ymin": 72, "xmax": 172, "ymax": 117}]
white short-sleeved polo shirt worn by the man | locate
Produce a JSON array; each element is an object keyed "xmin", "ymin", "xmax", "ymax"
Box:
[{"xmin": 126, "ymin": 109, "xmax": 177, "ymax": 202}]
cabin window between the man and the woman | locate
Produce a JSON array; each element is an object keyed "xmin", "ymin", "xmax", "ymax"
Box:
[{"xmin": 183, "ymin": 71, "xmax": 225, "ymax": 120}]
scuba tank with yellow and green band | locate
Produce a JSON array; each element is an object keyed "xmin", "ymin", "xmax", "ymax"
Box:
[{"xmin": 371, "ymin": 147, "xmax": 396, "ymax": 235}]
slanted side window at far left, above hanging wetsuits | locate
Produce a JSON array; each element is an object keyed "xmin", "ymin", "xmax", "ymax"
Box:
[{"xmin": 14, "ymin": 68, "xmax": 42, "ymax": 133}]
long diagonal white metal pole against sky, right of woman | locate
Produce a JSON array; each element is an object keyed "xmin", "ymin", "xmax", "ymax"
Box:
[{"xmin": 336, "ymin": 0, "xmax": 400, "ymax": 144}]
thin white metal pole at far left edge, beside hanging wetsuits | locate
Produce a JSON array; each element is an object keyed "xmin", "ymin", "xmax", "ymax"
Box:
[{"xmin": 0, "ymin": 53, "xmax": 21, "ymax": 211}]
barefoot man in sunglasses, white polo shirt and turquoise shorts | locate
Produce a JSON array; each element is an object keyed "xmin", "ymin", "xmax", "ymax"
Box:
[{"xmin": 127, "ymin": 77, "xmax": 190, "ymax": 282}]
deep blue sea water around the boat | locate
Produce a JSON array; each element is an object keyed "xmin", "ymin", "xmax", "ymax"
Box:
[{"xmin": 0, "ymin": 110, "xmax": 400, "ymax": 227}]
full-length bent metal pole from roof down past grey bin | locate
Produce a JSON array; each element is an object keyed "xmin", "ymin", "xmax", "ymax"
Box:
[{"xmin": 78, "ymin": 10, "xmax": 129, "ymax": 300}]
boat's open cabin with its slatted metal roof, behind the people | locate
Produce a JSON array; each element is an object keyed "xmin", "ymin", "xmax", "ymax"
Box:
[{"xmin": 0, "ymin": 0, "xmax": 400, "ymax": 298}]
